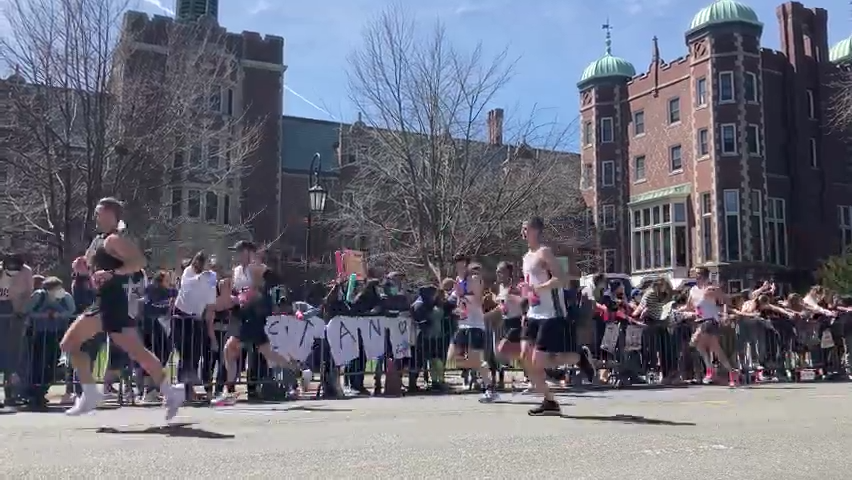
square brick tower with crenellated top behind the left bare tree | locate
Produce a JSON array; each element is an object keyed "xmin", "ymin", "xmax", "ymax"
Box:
[{"xmin": 123, "ymin": 8, "xmax": 286, "ymax": 265}]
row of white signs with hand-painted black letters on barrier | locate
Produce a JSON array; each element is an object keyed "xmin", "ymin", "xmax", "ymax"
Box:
[{"xmin": 266, "ymin": 315, "xmax": 414, "ymax": 365}]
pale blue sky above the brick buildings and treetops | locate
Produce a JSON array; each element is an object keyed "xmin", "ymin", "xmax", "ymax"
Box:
[{"xmin": 139, "ymin": 0, "xmax": 852, "ymax": 123}]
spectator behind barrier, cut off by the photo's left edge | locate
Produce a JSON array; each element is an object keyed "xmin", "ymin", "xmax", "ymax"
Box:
[{"xmin": 0, "ymin": 254, "xmax": 33, "ymax": 406}]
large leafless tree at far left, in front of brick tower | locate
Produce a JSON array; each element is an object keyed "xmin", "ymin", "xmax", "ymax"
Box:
[{"xmin": 0, "ymin": 0, "xmax": 260, "ymax": 272}]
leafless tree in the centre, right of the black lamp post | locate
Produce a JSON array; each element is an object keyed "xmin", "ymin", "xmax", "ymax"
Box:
[{"xmin": 330, "ymin": 6, "xmax": 583, "ymax": 282}]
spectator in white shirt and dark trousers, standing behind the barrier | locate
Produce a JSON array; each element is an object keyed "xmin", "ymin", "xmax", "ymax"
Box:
[{"xmin": 172, "ymin": 252, "xmax": 219, "ymax": 398}]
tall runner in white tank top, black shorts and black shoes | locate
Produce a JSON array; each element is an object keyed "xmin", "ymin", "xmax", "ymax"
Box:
[{"xmin": 521, "ymin": 217, "xmax": 580, "ymax": 416}]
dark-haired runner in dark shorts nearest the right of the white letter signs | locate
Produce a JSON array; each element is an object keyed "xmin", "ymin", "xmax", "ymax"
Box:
[{"xmin": 447, "ymin": 255, "xmax": 497, "ymax": 402}]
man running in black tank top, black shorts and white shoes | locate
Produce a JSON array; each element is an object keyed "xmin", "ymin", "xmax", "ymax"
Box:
[{"xmin": 61, "ymin": 197, "xmax": 184, "ymax": 420}]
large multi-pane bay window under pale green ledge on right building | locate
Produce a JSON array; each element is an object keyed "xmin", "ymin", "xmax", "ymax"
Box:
[{"xmin": 630, "ymin": 201, "xmax": 689, "ymax": 271}]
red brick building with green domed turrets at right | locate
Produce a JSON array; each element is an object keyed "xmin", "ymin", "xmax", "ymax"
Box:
[{"xmin": 578, "ymin": 0, "xmax": 852, "ymax": 289}]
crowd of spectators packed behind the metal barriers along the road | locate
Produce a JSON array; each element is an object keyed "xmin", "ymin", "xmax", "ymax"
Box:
[{"xmin": 0, "ymin": 249, "xmax": 852, "ymax": 408}]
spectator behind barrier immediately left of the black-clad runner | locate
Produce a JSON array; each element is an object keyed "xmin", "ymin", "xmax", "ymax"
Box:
[{"xmin": 26, "ymin": 277, "xmax": 75, "ymax": 409}]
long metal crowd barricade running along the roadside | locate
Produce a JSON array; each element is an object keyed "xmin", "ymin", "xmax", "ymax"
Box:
[{"xmin": 5, "ymin": 306, "xmax": 852, "ymax": 406}]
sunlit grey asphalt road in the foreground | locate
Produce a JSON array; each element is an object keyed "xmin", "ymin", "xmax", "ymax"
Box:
[{"xmin": 0, "ymin": 384, "xmax": 852, "ymax": 480}]
